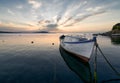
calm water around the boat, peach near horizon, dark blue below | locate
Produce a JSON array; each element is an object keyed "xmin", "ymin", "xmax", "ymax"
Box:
[{"xmin": 0, "ymin": 33, "xmax": 120, "ymax": 83}]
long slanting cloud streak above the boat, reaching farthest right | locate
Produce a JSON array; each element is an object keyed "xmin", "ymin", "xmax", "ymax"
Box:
[{"xmin": 61, "ymin": 5, "xmax": 106, "ymax": 27}]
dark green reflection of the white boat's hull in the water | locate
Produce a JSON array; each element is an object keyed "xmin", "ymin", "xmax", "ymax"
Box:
[{"xmin": 60, "ymin": 47, "xmax": 92, "ymax": 83}]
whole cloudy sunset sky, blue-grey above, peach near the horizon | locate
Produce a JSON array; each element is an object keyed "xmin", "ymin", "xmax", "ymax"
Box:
[{"xmin": 0, "ymin": 0, "xmax": 120, "ymax": 32}]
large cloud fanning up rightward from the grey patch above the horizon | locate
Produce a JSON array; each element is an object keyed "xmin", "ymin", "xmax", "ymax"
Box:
[{"xmin": 35, "ymin": 2, "xmax": 106, "ymax": 30}]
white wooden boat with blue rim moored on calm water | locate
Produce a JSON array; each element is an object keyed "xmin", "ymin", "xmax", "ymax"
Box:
[{"xmin": 60, "ymin": 35, "xmax": 96, "ymax": 62}]
